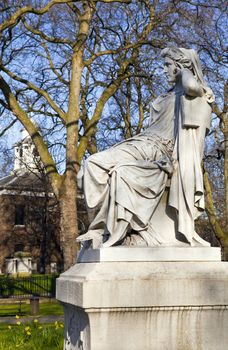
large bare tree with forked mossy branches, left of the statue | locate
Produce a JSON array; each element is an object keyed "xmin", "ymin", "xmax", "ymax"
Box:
[{"xmin": 0, "ymin": 0, "xmax": 164, "ymax": 269}]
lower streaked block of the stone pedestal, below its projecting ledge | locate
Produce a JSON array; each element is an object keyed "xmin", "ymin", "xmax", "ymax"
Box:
[{"xmin": 61, "ymin": 306, "xmax": 228, "ymax": 350}]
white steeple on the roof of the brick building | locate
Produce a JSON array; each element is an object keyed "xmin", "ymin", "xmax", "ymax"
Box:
[{"xmin": 14, "ymin": 129, "xmax": 39, "ymax": 171}]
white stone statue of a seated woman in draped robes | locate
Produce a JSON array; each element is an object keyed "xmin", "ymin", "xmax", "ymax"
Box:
[{"xmin": 77, "ymin": 47, "xmax": 213, "ymax": 247}]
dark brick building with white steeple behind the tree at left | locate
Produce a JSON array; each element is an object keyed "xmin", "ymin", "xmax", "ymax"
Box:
[{"xmin": 0, "ymin": 131, "xmax": 86, "ymax": 273}]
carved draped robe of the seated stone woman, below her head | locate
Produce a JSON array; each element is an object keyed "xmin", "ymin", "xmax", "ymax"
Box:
[{"xmin": 84, "ymin": 91, "xmax": 211, "ymax": 246}]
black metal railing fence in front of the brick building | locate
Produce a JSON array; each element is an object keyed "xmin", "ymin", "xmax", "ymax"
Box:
[{"xmin": 0, "ymin": 275, "xmax": 58, "ymax": 299}]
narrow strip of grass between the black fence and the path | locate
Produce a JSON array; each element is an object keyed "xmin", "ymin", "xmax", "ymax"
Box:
[{"xmin": 0, "ymin": 301, "xmax": 63, "ymax": 317}]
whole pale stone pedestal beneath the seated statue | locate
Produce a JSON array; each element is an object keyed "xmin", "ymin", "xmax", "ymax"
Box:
[{"xmin": 57, "ymin": 247, "xmax": 228, "ymax": 350}]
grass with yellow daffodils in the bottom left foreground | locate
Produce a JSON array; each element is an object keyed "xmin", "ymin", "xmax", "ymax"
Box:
[{"xmin": 0, "ymin": 319, "xmax": 64, "ymax": 350}]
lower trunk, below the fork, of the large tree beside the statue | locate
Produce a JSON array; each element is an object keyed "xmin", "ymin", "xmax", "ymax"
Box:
[{"xmin": 59, "ymin": 171, "xmax": 78, "ymax": 271}]
